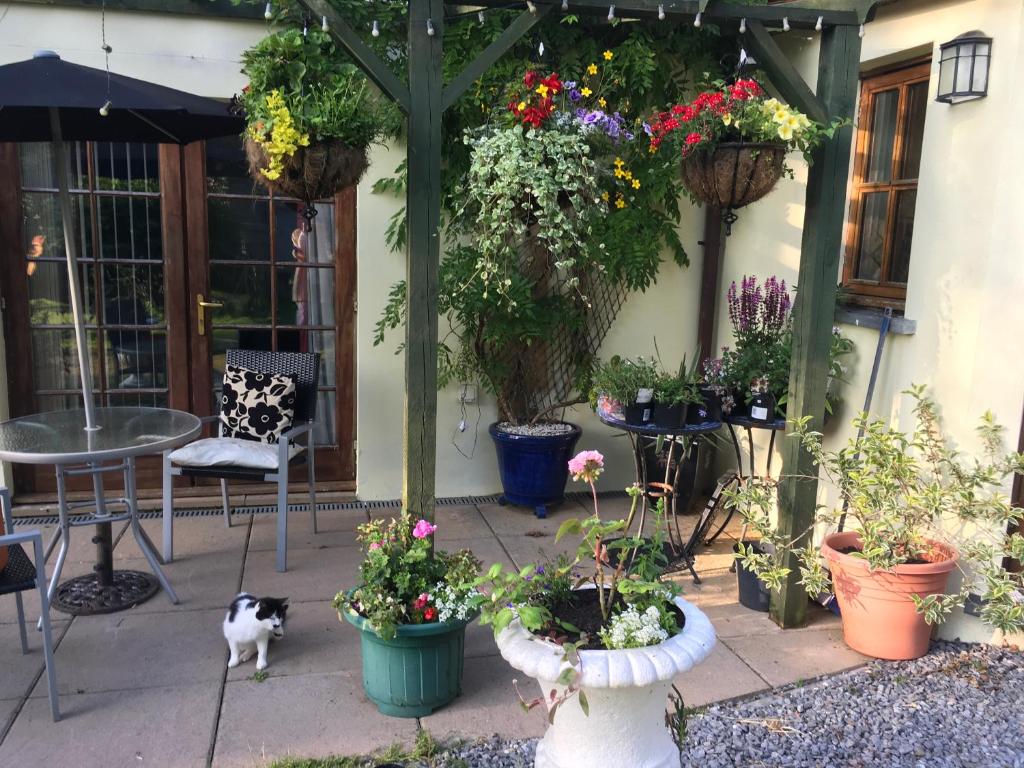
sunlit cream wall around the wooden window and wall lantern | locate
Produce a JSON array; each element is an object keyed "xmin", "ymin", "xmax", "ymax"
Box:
[{"xmin": 718, "ymin": 0, "xmax": 1024, "ymax": 640}]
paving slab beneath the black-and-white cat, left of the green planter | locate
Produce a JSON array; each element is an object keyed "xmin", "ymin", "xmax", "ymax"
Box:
[{"xmin": 226, "ymin": 600, "xmax": 361, "ymax": 682}]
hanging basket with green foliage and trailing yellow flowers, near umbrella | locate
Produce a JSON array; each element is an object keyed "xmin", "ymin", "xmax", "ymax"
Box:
[{"xmin": 239, "ymin": 26, "xmax": 400, "ymax": 204}]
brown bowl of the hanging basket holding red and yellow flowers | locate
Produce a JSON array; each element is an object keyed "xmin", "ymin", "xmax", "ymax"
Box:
[{"xmin": 683, "ymin": 142, "xmax": 785, "ymax": 209}]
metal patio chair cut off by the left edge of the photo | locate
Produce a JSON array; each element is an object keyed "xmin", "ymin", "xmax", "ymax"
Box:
[{"xmin": 0, "ymin": 487, "xmax": 60, "ymax": 722}]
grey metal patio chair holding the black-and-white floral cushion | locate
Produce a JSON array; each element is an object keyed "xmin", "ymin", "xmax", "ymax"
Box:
[{"xmin": 163, "ymin": 349, "xmax": 319, "ymax": 572}]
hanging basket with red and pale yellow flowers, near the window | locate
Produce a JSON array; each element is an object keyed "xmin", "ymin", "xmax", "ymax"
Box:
[{"xmin": 648, "ymin": 79, "xmax": 835, "ymax": 231}]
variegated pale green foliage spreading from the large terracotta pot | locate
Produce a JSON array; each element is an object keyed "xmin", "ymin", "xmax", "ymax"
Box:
[{"xmin": 728, "ymin": 386, "xmax": 1024, "ymax": 632}]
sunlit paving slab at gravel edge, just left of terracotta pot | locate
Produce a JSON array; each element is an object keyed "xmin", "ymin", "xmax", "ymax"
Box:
[{"xmin": 728, "ymin": 628, "xmax": 870, "ymax": 686}]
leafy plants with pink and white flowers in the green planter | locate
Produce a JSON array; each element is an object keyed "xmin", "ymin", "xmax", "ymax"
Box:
[{"xmin": 334, "ymin": 511, "xmax": 480, "ymax": 640}]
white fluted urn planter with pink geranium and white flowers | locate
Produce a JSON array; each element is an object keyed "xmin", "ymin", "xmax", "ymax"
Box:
[{"xmin": 481, "ymin": 451, "xmax": 715, "ymax": 768}]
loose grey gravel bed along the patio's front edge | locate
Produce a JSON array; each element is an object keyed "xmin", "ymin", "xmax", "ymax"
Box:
[{"xmin": 391, "ymin": 642, "xmax": 1024, "ymax": 768}]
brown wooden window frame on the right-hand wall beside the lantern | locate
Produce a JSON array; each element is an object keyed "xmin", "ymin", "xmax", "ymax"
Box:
[{"xmin": 843, "ymin": 56, "xmax": 932, "ymax": 309}]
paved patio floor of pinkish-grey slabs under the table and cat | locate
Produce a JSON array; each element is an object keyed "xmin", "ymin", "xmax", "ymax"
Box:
[{"xmin": 0, "ymin": 498, "xmax": 864, "ymax": 768}]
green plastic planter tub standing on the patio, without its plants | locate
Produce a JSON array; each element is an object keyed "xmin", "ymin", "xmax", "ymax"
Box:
[{"xmin": 339, "ymin": 610, "xmax": 476, "ymax": 718}]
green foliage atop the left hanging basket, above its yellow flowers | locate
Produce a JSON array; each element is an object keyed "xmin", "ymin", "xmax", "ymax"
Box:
[{"xmin": 241, "ymin": 26, "xmax": 400, "ymax": 146}]
